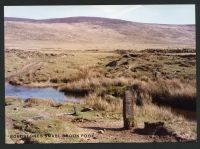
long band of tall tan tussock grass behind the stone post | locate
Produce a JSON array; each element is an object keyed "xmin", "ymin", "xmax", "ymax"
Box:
[{"xmin": 60, "ymin": 74, "xmax": 196, "ymax": 111}]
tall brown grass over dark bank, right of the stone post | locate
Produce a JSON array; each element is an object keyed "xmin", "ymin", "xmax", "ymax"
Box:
[{"xmin": 132, "ymin": 79, "xmax": 196, "ymax": 111}]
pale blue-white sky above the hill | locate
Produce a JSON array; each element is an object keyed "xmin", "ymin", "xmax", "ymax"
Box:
[{"xmin": 4, "ymin": 5, "xmax": 195, "ymax": 24}]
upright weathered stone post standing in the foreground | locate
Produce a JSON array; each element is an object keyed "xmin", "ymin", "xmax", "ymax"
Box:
[{"xmin": 123, "ymin": 90, "xmax": 134, "ymax": 129}]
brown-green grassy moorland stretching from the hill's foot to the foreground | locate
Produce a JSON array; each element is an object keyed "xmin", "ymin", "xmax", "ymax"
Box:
[{"xmin": 5, "ymin": 49, "xmax": 197, "ymax": 143}]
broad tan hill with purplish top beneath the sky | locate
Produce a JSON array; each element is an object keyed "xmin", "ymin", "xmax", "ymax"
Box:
[{"xmin": 4, "ymin": 17, "xmax": 195, "ymax": 50}]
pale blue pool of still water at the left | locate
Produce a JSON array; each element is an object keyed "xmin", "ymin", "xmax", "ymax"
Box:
[{"xmin": 5, "ymin": 83, "xmax": 83, "ymax": 102}]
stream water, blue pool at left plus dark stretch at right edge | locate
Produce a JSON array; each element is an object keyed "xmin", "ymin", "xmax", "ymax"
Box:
[{"xmin": 5, "ymin": 83, "xmax": 196, "ymax": 120}]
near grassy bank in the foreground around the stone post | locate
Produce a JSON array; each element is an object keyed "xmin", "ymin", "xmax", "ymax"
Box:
[{"xmin": 5, "ymin": 97, "xmax": 197, "ymax": 143}]
